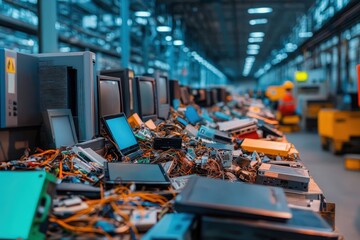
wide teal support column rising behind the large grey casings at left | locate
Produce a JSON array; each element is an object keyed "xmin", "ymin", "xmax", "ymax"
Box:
[{"xmin": 38, "ymin": 0, "xmax": 59, "ymax": 53}]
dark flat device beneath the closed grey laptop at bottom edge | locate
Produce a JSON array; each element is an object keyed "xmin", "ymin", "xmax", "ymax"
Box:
[{"xmin": 199, "ymin": 208, "xmax": 339, "ymax": 240}]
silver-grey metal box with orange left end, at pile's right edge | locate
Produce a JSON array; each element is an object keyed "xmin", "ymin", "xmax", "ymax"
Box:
[{"xmin": 256, "ymin": 163, "xmax": 310, "ymax": 191}]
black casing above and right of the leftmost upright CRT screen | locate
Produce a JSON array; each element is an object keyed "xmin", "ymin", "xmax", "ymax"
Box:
[{"xmin": 100, "ymin": 68, "xmax": 139, "ymax": 117}]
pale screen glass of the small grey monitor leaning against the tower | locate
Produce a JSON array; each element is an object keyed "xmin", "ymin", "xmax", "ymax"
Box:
[{"xmin": 51, "ymin": 115, "xmax": 76, "ymax": 148}]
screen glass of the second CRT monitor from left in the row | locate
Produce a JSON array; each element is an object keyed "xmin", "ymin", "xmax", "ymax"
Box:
[{"xmin": 139, "ymin": 81, "xmax": 155, "ymax": 116}]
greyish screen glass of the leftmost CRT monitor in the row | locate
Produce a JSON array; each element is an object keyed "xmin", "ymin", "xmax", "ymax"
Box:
[{"xmin": 99, "ymin": 80, "xmax": 122, "ymax": 117}]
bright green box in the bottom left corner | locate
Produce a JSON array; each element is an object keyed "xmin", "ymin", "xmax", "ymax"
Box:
[{"xmin": 0, "ymin": 171, "xmax": 56, "ymax": 239}]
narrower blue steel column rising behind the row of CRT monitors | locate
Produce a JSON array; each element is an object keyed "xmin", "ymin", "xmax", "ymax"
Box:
[{"xmin": 120, "ymin": 0, "xmax": 130, "ymax": 68}]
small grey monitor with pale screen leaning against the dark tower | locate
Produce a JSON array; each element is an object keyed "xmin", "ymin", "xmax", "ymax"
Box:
[{"xmin": 43, "ymin": 109, "xmax": 78, "ymax": 148}]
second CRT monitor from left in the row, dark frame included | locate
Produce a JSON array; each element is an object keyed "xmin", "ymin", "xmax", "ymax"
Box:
[{"xmin": 135, "ymin": 76, "xmax": 158, "ymax": 122}]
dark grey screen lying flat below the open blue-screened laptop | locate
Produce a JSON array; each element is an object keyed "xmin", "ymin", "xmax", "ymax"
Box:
[{"xmin": 108, "ymin": 163, "xmax": 167, "ymax": 182}]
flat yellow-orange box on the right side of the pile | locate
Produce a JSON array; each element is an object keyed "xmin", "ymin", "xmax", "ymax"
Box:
[{"xmin": 241, "ymin": 138, "xmax": 292, "ymax": 157}]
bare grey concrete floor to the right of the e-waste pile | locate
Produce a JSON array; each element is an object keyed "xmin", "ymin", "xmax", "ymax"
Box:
[{"xmin": 287, "ymin": 132, "xmax": 360, "ymax": 240}]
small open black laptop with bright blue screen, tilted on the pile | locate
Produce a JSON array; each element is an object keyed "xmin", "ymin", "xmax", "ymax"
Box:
[{"xmin": 102, "ymin": 113, "xmax": 143, "ymax": 160}]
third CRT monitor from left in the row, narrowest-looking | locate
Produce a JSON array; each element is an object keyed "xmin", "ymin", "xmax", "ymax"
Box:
[{"xmin": 156, "ymin": 73, "xmax": 170, "ymax": 119}]
